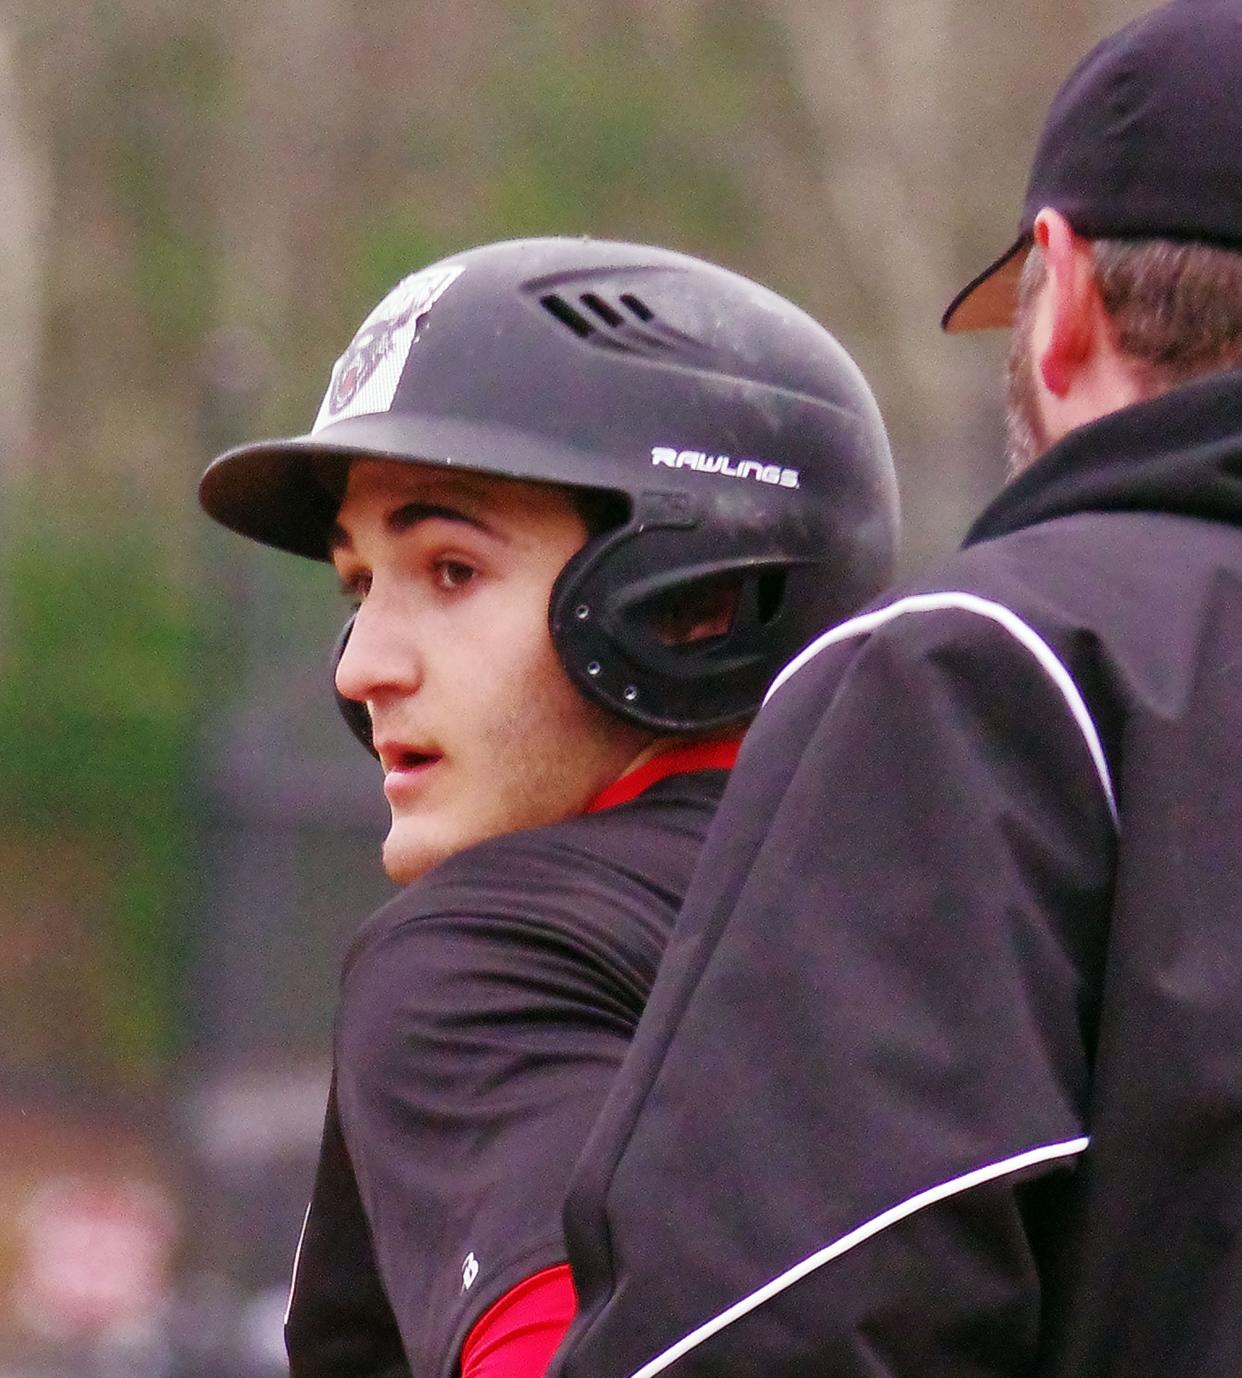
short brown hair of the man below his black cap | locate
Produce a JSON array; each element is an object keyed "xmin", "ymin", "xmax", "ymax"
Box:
[{"xmin": 1019, "ymin": 238, "xmax": 1242, "ymax": 395}]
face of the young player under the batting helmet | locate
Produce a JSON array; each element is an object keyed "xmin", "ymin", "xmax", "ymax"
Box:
[{"xmin": 332, "ymin": 460, "xmax": 658, "ymax": 883}]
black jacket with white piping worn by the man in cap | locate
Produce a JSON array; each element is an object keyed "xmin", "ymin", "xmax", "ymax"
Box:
[{"xmin": 551, "ymin": 373, "xmax": 1242, "ymax": 1378}]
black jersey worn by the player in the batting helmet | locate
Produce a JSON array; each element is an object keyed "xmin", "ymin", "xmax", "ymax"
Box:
[{"xmin": 285, "ymin": 769, "xmax": 725, "ymax": 1378}]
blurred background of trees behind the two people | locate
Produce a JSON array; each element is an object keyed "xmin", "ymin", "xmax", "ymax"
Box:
[{"xmin": 0, "ymin": 0, "xmax": 1146, "ymax": 1378}]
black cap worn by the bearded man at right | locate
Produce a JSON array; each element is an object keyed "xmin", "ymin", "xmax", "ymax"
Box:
[{"xmin": 940, "ymin": 0, "xmax": 1242, "ymax": 332}]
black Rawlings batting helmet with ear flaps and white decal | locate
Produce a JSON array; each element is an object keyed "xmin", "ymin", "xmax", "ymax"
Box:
[{"xmin": 200, "ymin": 238, "xmax": 897, "ymax": 741}]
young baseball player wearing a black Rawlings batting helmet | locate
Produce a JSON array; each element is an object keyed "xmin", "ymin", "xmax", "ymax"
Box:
[{"xmin": 201, "ymin": 240, "xmax": 896, "ymax": 1378}]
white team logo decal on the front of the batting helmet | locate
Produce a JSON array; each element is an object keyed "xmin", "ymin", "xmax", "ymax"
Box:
[{"xmin": 313, "ymin": 263, "xmax": 465, "ymax": 431}]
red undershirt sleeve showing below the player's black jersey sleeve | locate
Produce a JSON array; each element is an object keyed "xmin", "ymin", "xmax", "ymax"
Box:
[{"xmin": 462, "ymin": 1264, "xmax": 578, "ymax": 1378}]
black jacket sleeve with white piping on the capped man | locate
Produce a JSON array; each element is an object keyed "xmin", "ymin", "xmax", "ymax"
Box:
[{"xmin": 553, "ymin": 610, "xmax": 1115, "ymax": 1378}]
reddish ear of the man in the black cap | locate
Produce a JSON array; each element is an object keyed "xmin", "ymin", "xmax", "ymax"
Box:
[{"xmin": 1034, "ymin": 207, "xmax": 1103, "ymax": 397}]
